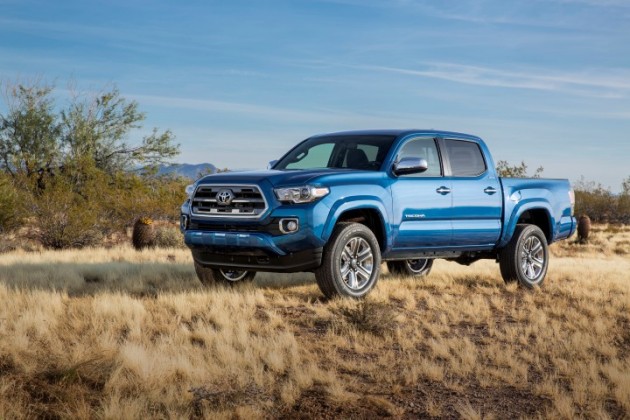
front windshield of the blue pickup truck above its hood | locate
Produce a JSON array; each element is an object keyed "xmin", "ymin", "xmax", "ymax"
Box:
[{"xmin": 274, "ymin": 135, "xmax": 396, "ymax": 171}]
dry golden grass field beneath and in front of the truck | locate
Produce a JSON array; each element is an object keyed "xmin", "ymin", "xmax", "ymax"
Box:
[{"xmin": 0, "ymin": 226, "xmax": 630, "ymax": 419}]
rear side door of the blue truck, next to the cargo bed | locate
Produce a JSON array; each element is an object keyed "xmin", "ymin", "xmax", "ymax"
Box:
[{"xmin": 443, "ymin": 139, "xmax": 503, "ymax": 248}]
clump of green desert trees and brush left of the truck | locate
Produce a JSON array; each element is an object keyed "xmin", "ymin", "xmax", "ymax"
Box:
[{"xmin": 0, "ymin": 79, "xmax": 186, "ymax": 248}]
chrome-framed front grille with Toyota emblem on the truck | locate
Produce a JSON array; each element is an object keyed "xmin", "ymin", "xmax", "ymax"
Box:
[{"xmin": 191, "ymin": 185, "xmax": 267, "ymax": 218}]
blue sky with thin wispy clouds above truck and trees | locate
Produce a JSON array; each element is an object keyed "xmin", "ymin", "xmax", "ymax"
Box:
[{"xmin": 0, "ymin": 0, "xmax": 630, "ymax": 191}]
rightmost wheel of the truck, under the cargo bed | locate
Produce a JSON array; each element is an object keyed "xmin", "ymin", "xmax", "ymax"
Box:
[{"xmin": 499, "ymin": 224, "xmax": 549, "ymax": 289}]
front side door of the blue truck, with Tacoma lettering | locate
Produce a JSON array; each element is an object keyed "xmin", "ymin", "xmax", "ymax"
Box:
[{"xmin": 391, "ymin": 137, "xmax": 452, "ymax": 251}]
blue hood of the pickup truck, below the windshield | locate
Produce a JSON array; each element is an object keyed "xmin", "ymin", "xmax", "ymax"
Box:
[{"xmin": 199, "ymin": 169, "xmax": 351, "ymax": 187}]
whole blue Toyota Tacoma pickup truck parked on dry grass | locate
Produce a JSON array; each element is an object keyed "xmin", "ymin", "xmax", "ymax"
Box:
[{"xmin": 180, "ymin": 130, "xmax": 576, "ymax": 298}]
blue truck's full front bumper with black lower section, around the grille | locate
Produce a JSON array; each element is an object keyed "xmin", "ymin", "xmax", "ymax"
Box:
[{"xmin": 181, "ymin": 183, "xmax": 330, "ymax": 273}]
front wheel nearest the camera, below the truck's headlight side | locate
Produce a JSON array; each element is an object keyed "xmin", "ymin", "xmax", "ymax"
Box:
[{"xmin": 315, "ymin": 223, "xmax": 381, "ymax": 298}]
